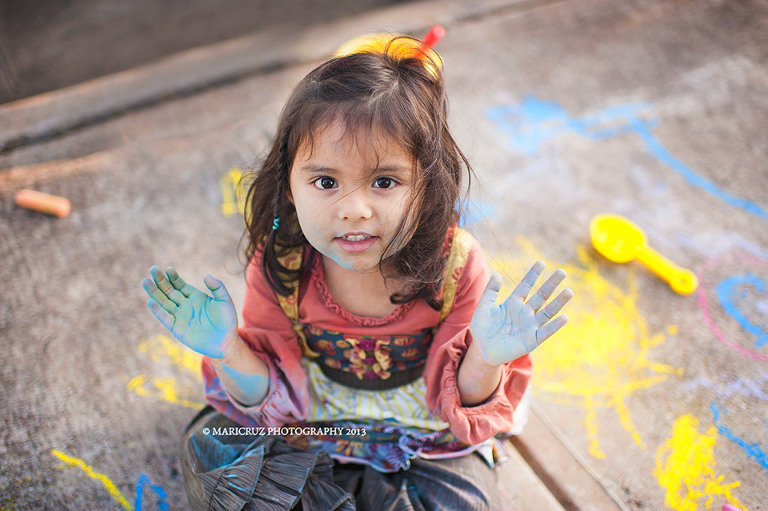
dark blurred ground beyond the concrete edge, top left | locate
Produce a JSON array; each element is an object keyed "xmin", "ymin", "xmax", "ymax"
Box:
[{"xmin": 0, "ymin": 0, "xmax": 414, "ymax": 103}]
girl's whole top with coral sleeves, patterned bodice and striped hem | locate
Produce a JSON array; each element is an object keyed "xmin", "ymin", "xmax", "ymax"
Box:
[{"xmin": 203, "ymin": 232, "xmax": 531, "ymax": 472}]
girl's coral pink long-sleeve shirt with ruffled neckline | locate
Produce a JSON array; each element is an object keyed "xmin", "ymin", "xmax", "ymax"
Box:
[{"xmin": 202, "ymin": 234, "xmax": 532, "ymax": 444}]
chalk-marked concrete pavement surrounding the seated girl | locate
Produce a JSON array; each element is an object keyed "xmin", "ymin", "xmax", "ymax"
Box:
[{"xmin": 0, "ymin": 0, "xmax": 768, "ymax": 511}]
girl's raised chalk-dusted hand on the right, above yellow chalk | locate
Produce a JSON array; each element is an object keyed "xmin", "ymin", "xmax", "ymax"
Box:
[{"xmin": 470, "ymin": 261, "xmax": 573, "ymax": 365}]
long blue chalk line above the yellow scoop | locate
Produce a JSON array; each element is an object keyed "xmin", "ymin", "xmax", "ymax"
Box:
[{"xmin": 485, "ymin": 95, "xmax": 768, "ymax": 220}]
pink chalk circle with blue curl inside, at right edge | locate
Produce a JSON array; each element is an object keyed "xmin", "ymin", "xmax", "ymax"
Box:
[{"xmin": 696, "ymin": 255, "xmax": 768, "ymax": 362}]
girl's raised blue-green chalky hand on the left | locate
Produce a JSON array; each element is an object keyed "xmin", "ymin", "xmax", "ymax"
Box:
[{"xmin": 141, "ymin": 266, "xmax": 237, "ymax": 358}]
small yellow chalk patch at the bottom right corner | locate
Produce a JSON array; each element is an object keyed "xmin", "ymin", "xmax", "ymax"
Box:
[{"xmin": 653, "ymin": 415, "xmax": 746, "ymax": 511}]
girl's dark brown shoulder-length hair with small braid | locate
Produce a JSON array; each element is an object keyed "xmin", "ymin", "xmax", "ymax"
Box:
[{"xmin": 244, "ymin": 38, "xmax": 471, "ymax": 310}]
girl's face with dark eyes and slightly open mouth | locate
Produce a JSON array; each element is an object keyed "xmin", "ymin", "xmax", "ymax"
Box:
[{"xmin": 290, "ymin": 120, "xmax": 414, "ymax": 273}]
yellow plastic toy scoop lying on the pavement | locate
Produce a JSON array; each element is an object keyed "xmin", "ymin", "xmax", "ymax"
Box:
[{"xmin": 589, "ymin": 215, "xmax": 699, "ymax": 295}]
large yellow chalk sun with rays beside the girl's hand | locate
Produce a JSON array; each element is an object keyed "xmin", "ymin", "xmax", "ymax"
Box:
[{"xmin": 488, "ymin": 237, "xmax": 683, "ymax": 458}]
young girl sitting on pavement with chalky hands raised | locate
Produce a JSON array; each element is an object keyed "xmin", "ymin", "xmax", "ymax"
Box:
[{"xmin": 143, "ymin": 39, "xmax": 572, "ymax": 510}]
